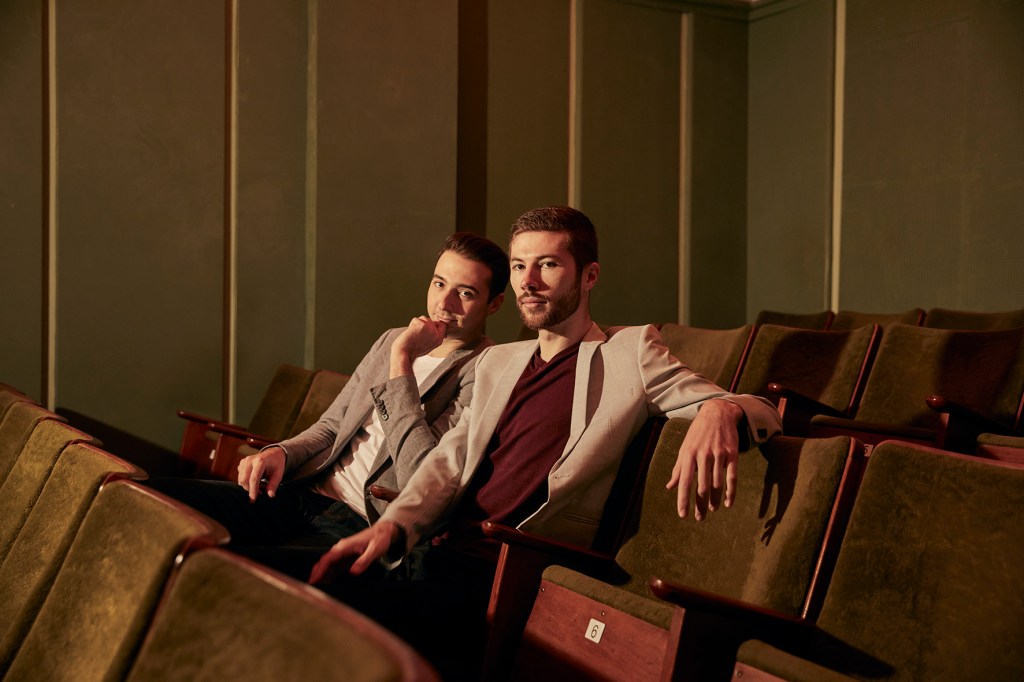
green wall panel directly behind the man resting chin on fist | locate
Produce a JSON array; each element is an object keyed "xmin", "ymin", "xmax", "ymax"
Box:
[{"xmin": 315, "ymin": 0, "xmax": 458, "ymax": 372}]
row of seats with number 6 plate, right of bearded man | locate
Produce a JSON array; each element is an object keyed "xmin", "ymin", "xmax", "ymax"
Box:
[{"xmin": 484, "ymin": 420, "xmax": 1024, "ymax": 682}]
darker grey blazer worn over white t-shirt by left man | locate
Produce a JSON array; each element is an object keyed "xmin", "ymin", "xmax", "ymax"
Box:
[{"xmin": 276, "ymin": 329, "xmax": 494, "ymax": 522}]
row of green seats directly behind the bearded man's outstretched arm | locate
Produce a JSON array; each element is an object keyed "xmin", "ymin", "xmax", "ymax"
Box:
[{"xmin": 660, "ymin": 323, "xmax": 1024, "ymax": 461}]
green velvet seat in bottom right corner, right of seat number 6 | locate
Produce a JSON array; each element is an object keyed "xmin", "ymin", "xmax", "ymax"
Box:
[{"xmin": 736, "ymin": 441, "xmax": 1024, "ymax": 682}]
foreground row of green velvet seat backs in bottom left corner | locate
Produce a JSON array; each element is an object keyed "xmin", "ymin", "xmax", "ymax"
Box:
[{"xmin": 0, "ymin": 386, "xmax": 437, "ymax": 682}]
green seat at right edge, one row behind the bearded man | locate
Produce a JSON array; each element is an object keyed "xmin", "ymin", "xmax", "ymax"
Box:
[{"xmin": 810, "ymin": 324, "xmax": 1024, "ymax": 454}]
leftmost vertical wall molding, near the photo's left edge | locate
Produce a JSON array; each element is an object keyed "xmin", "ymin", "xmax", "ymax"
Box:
[{"xmin": 42, "ymin": 0, "xmax": 57, "ymax": 410}]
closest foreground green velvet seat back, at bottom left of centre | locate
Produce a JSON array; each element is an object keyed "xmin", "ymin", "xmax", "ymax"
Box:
[{"xmin": 127, "ymin": 549, "xmax": 437, "ymax": 682}]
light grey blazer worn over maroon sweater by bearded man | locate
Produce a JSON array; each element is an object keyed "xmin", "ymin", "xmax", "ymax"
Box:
[{"xmin": 383, "ymin": 325, "xmax": 781, "ymax": 551}]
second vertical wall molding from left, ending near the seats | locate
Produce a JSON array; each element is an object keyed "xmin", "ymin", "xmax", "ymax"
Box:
[{"xmin": 223, "ymin": 0, "xmax": 239, "ymax": 423}]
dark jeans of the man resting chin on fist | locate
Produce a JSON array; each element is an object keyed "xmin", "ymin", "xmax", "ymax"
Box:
[{"xmin": 147, "ymin": 478, "xmax": 368, "ymax": 581}]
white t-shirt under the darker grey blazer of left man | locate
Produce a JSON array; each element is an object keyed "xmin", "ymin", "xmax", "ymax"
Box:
[{"xmin": 312, "ymin": 355, "xmax": 444, "ymax": 518}]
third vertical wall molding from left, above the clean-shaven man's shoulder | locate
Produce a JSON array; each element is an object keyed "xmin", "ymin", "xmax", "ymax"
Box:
[{"xmin": 302, "ymin": 0, "xmax": 319, "ymax": 368}]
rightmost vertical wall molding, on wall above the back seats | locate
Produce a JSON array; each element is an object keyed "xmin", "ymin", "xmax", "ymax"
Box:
[{"xmin": 825, "ymin": 0, "xmax": 846, "ymax": 310}]
